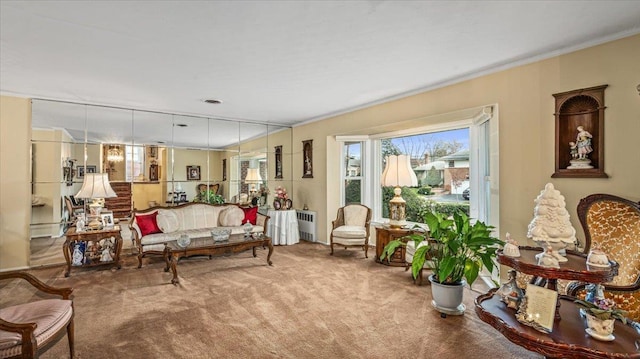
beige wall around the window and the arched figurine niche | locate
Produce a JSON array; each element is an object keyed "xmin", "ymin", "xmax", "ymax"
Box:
[{"xmin": 293, "ymin": 35, "xmax": 640, "ymax": 246}]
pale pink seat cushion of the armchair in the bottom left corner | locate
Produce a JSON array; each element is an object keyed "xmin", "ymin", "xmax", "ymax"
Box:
[{"xmin": 0, "ymin": 299, "xmax": 73, "ymax": 357}]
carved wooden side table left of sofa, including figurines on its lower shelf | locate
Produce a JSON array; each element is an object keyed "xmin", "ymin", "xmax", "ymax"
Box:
[{"xmin": 62, "ymin": 225, "xmax": 122, "ymax": 277}]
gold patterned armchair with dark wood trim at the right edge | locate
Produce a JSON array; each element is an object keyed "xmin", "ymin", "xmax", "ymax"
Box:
[{"xmin": 567, "ymin": 194, "xmax": 640, "ymax": 321}]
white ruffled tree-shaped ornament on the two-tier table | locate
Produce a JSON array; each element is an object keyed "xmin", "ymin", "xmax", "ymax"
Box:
[{"xmin": 527, "ymin": 183, "xmax": 576, "ymax": 262}]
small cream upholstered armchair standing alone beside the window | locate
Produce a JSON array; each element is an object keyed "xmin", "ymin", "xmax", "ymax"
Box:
[{"xmin": 330, "ymin": 204, "xmax": 371, "ymax": 258}]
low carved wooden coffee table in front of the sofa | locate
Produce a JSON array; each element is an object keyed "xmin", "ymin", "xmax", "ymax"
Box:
[{"xmin": 164, "ymin": 234, "xmax": 273, "ymax": 284}]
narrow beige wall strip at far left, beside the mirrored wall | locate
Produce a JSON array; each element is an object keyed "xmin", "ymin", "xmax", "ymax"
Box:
[{"xmin": 0, "ymin": 96, "xmax": 31, "ymax": 270}]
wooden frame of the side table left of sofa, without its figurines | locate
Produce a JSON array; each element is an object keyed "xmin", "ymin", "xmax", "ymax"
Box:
[{"xmin": 62, "ymin": 225, "xmax": 122, "ymax": 277}]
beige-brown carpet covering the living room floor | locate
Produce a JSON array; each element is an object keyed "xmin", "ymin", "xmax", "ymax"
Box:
[{"xmin": 10, "ymin": 242, "xmax": 541, "ymax": 359}]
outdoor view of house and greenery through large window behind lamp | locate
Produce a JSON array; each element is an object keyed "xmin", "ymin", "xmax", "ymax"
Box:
[{"xmin": 380, "ymin": 128, "xmax": 470, "ymax": 223}]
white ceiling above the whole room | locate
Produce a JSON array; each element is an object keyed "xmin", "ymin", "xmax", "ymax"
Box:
[{"xmin": 0, "ymin": 0, "xmax": 640, "ymax": 125}]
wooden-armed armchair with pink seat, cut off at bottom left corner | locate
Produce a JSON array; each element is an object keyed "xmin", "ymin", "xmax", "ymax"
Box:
[{"xmin": 0, "ymin": 272, "xmax": 74, "ymax": 358}]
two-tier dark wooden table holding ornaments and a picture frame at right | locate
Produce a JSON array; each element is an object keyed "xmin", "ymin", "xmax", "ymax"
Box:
[{"xmin": 475, "ymin": 247, "xmax": 640, "ymax": 359}]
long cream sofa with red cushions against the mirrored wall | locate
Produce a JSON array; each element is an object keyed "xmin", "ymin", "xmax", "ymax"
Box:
[{"xmin": 129, "ymin": 203, "xmax": 269, "ymax": 268}]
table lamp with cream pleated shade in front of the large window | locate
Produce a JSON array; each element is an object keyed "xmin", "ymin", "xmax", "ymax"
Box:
[{"xmin": 381, "ymin": 155, "xmax": 418, "ymax": 228}]
